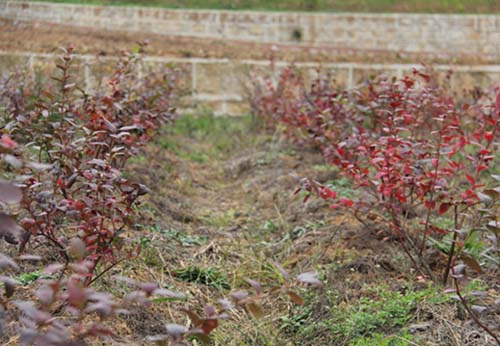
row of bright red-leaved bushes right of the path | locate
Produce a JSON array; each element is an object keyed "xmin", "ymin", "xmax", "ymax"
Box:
[{"xmin": 251, "ymin": 65, "xmax": 500, "ymax": 343}]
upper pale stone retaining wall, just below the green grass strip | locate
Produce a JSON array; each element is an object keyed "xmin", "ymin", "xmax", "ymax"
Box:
[{"xmin": 0, "ymin": 0, "xmax": 500, "ymax": 56}]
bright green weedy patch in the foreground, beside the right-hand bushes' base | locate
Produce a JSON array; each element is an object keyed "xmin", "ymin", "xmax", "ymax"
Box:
[{"xmin": 288, "ymin": 285, "xmax": 451, "ymax": 345}]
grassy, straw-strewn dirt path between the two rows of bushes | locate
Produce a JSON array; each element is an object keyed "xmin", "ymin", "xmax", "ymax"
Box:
[{"xmin": 86, "ymin": 116, "xmax": 496, "ymax": 346}]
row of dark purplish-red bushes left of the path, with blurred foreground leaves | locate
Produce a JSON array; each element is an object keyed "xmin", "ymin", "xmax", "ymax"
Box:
[{"xmin": 0, "ymin": 46, "xmax": 321, "ymax": 346}]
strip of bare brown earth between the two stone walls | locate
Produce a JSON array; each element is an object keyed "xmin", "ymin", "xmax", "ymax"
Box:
[{"xmin": 0, "ymin": 19, "xmax": 498, "ymax": 64}]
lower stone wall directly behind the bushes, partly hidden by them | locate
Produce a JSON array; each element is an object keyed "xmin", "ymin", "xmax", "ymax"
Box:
[{"xmin": 0, "ymin": 52, "xmax": 500, "ymax": 115}]
